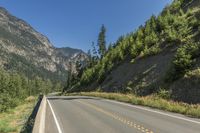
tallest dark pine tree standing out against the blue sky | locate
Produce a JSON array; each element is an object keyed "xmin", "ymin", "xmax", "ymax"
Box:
[{"xmin": 97, "ymin": 25, "xmax": 106, "ymax": 59}]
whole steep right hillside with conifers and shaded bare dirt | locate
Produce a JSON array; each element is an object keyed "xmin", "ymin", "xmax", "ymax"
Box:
[{"xmin": 70, "ymin": 0, "xmax": 200, "ymax": 103}]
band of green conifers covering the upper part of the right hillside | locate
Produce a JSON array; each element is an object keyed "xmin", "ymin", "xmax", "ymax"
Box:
[{"xmin": 68, "ymin": 0, "xmax": 200, "ymax": 91}]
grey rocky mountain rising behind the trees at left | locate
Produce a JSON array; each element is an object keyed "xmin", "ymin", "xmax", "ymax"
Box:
[{"xmin": 0, "ymin": 7, "xmax": 87, "ymax": 81}]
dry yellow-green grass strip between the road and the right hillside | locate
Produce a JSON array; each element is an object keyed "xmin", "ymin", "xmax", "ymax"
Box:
[{"xmin": 65, "ymin": 92, "xmax": 200, "ymax": 118}]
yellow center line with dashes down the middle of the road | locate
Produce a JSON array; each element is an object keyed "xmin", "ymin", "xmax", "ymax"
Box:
[{"xmin": 77, "ymin": 100, "xmax": 154, "ymax": 133}]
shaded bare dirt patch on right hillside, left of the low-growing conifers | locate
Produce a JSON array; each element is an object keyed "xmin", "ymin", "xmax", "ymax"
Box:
[{"xmin": 101, "ymin": 48, "xmax": 175, "ymax": 94}]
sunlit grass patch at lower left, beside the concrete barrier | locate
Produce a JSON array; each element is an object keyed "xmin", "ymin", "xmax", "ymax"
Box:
[{"xmin": 0, "ymin": 97, "xmax": 37, "ymax": 133}]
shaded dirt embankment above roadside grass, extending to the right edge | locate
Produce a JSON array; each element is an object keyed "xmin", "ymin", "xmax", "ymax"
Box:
[{"xmin": 93, "ymin": 47, "xmax": 200, "ymax": 103}]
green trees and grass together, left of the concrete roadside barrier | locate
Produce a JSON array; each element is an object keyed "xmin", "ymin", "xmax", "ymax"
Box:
[{"xmin": 0, "ymin": 64, "xmax": 61, "ymax": 133}]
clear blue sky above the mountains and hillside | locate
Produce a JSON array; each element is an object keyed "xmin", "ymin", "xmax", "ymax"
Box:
[{"xmin": 0, "ymin": 0, "xmax": 172, "ymax": 51}]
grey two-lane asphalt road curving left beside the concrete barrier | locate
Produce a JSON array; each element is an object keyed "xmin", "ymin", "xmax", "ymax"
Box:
[{"xmin": 45, "ymin": 96, "xmax": 200, "ymax": 133}]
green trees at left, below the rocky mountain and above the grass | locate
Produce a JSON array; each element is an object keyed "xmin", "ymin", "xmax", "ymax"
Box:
[{"xmin": 0, "ymin": 69, "xmax": 62, "ymax": 112}]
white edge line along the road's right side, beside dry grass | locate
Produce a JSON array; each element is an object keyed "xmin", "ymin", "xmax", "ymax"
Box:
[{"xmin": 104, "ymin": 99, "xmax": 200, "ymax": 124}]
